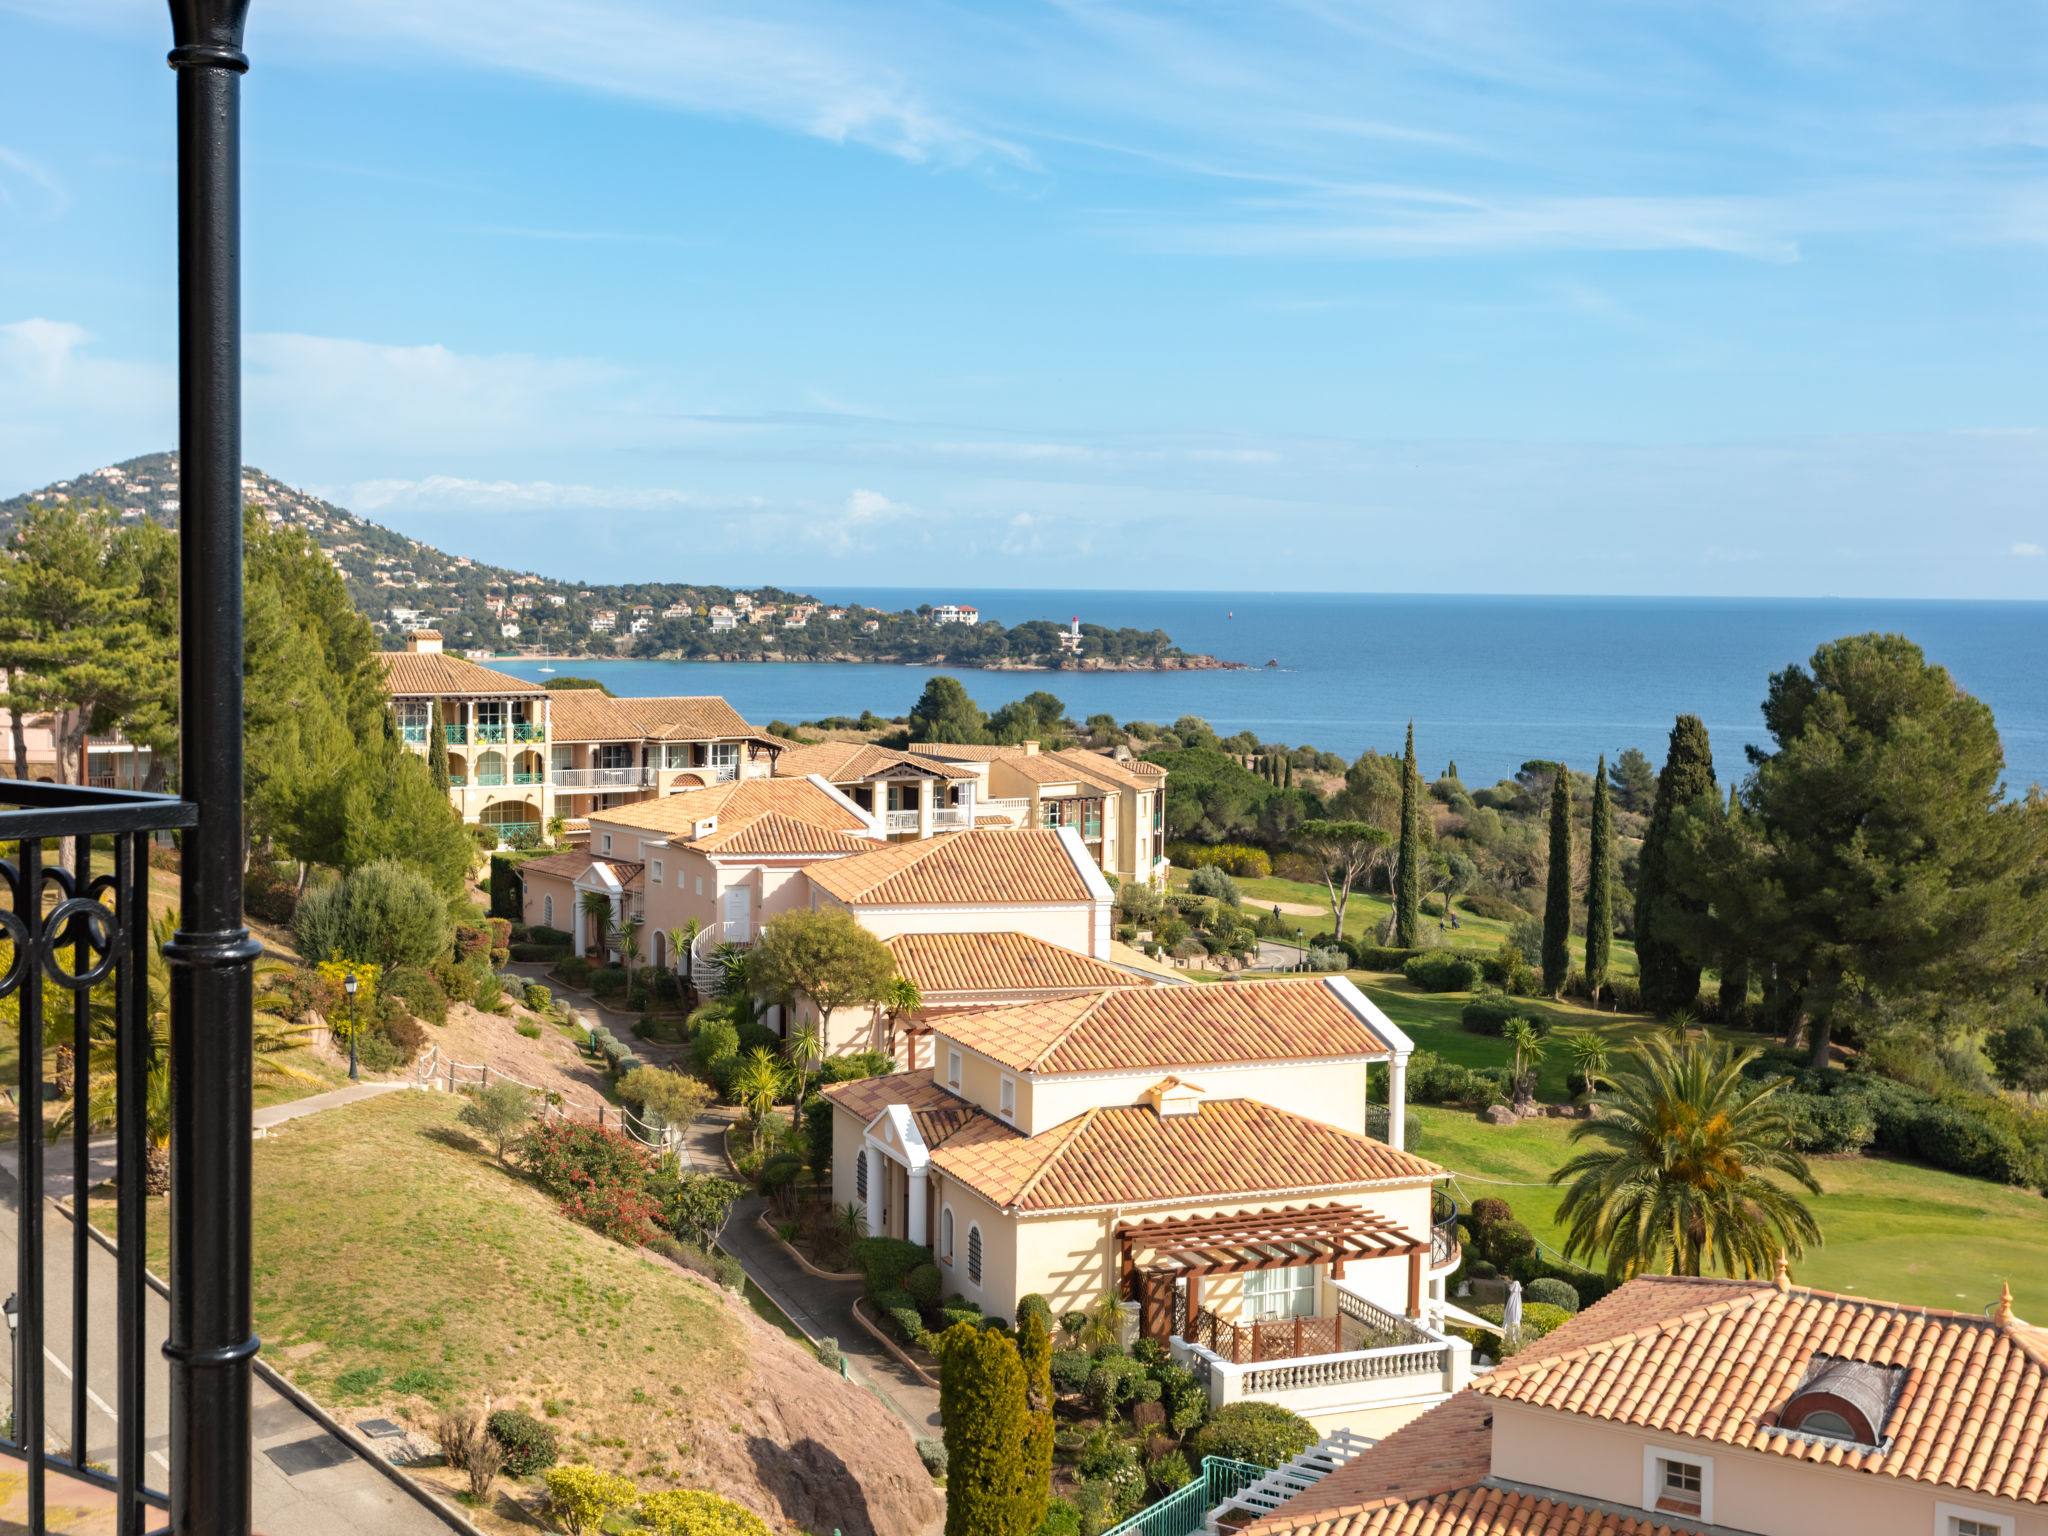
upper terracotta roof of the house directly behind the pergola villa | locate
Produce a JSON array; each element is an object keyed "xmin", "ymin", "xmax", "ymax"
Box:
[{"xmin": 802, "ymin": 835, "xmax": 1098, "ymax": 905}]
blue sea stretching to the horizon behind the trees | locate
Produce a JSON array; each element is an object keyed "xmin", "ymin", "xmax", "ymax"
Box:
[{"xmin": 496, "ymin": 588, "xmax": 2048, "ymax": 793}]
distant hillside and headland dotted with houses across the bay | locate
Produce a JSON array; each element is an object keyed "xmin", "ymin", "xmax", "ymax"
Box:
[{"xmin": 0, "ymin": 453, "xmax": 1219, "ymax": 670}]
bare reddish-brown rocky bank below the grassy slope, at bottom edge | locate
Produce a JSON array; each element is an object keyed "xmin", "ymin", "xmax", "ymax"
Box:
[{"xmin": 649, "ymin": 1255, "xmax": 946, "ymax": 1536}]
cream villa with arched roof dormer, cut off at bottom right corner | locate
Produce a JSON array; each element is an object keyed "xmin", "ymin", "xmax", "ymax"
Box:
[{"xmin": 1245, "ymin": 1272, "xmax": 2048, "ymax": 1536}]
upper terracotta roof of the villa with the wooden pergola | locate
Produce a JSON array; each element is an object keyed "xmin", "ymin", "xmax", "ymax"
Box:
[{"xmin": 934, "ymin": 978, "xmax": 1407, "ymax": 1073}]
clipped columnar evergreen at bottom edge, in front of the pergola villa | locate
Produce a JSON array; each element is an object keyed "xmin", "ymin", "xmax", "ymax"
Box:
[{"xmin": 938, "ymin": 1323, "xmax": 1044, "ymax": 1536}]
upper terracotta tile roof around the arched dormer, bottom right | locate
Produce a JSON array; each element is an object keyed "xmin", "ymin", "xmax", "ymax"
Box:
[{"xmin": 1475, "ymin": 1280, "xmax": 2048, "ymax": 1503}]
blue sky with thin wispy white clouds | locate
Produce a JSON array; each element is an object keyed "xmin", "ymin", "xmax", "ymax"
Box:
[{"xmin": 0, "ymin": 0, "xmax": 2048, "ymax": 598}]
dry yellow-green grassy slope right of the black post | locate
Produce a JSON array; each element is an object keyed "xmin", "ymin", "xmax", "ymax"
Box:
[{"xmin": 94, "ymin": 1094, "xmax": 743, "ymax": 1479}]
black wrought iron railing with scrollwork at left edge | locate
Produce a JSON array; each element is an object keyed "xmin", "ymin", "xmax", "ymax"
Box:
[{"xmin": 0, "ymin": 782, "xmax": 197, "ymax": 1536}]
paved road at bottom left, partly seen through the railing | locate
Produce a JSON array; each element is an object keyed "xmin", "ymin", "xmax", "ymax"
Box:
[{"xmin": 0, "ymin": 1149, "xmax": 451, "ymax": 1536}]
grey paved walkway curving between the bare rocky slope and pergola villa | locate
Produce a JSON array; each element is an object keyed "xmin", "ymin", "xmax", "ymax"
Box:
[{"xmin": 684, "ymin": 1108, "xmax": 940, "ymax": 1440}]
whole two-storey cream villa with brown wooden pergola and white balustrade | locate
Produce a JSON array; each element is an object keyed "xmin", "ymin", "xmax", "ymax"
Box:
[{"xmin": 827, "ymin": 974, "xmax": 1470, "ymax": 1434}]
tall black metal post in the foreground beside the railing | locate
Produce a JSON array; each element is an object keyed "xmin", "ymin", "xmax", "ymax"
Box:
[{"xmin": 164, "ymin": 0, "xmax": 262, "ymax": 1536}]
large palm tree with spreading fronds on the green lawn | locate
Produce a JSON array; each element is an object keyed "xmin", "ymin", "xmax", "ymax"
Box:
[{"xmin": 1550, "ymin": 1034, "xmax": 1821, "ymax": 1280}]
